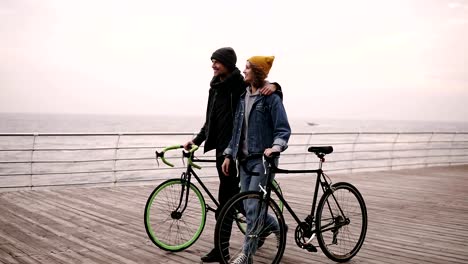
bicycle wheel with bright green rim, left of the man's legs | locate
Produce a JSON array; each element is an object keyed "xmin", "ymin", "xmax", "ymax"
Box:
[{"xmin": 145, "ymin": 179, "xmax": 206, "ymax": 252}]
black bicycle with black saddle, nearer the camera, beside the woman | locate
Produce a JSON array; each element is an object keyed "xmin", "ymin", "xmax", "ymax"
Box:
[{"xmin": 215, "ymin": 146, "xmax": 367, "ymax": 263}]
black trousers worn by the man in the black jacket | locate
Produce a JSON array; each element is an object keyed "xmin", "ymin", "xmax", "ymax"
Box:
[{"xmin": 215, "ymin": 156, "xmax": 240, "ymax": 219}]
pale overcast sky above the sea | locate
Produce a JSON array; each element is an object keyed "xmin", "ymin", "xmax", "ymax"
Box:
[{"xmin": 0, "ymin": 0, "xmax": 468, "ymax": 122}]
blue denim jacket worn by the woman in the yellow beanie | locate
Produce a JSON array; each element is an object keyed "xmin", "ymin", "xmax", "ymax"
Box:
[{"xmin": 223, "ymin": 93, "xmax": 291, "ymax": 159}]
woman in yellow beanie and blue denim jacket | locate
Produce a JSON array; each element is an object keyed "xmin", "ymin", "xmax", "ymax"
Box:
[{"xmin": 222, "ymin": 56, "xmax": 291, "ymax": 263}]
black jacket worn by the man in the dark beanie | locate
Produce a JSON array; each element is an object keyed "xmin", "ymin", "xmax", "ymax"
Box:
[{"xmin": 193, "ymin": 68, "xmax": 282, "ymax": 156}]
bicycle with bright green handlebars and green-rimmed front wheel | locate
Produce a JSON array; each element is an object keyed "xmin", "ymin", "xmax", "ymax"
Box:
[{"xmin": 144, "ymin": 145, "xmax": 282, "ymax": 252}]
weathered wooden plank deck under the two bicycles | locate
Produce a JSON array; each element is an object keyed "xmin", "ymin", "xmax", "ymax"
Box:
[{"xmin": 0, "ymin": 165, "xmax": 468, "ymax": 264}]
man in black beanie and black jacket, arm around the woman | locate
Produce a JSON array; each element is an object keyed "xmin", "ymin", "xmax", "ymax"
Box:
[{"xmin": 184, "ymin": 47, "xmax": 281, "ymax": 262}]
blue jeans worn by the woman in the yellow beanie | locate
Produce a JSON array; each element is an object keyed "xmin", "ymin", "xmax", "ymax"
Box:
[{"xmin": 239, "ymin": 158, "xmax": 279, "ymax": 255}]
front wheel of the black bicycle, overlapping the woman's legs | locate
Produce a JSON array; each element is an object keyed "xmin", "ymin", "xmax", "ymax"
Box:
[{"xmin": 215, "ymin": 192, "xmax": 286, "ymax": 264}]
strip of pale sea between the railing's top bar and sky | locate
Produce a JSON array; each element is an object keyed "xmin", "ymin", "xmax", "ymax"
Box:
[{"xmin": 0, "ymin": 113, "xmax": 468, "ymax": 133}]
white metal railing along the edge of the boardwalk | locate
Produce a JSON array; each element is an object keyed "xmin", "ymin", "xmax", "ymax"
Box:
[{"xmin": 0, "ymin": 132, "xmax": 468, "ymax": 190}]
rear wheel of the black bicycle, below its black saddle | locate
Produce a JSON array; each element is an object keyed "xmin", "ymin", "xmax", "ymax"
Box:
[{"xmin": 316, "ymin": 182, "xmax": 367, "ymax": 262}]
